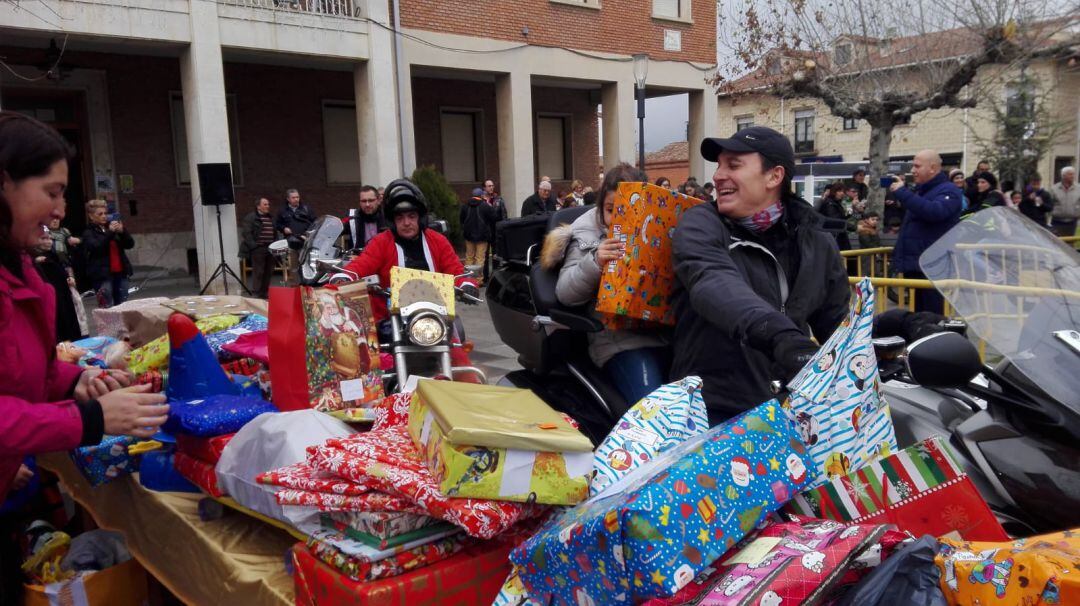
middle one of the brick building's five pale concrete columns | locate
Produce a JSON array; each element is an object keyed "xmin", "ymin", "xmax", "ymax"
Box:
[{"xmin": 495, "ymin": 72, "xmax": 537, "ymax": 217}]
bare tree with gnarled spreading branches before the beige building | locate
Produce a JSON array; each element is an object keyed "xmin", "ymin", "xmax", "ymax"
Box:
[{"xmin": 716, "ymin": 0, "xmax": 1080, "ymax": 219}]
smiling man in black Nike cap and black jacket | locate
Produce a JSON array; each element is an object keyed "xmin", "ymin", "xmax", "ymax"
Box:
[{"xmin": 672, "ymin": 126, "xmax": 850, "ymax": 425}]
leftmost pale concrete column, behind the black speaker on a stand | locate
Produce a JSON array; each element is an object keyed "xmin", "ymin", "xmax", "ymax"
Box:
[{"xmin": 180, "ymin": 0, "xmax": 240, "ymax": 293}]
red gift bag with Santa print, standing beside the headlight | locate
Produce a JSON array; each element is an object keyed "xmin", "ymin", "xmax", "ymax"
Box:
[{"xmin": 269, "ymin": 283, "xmax": 382, "ymax": 410}]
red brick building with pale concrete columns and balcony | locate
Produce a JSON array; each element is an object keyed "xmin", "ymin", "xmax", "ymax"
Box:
[{"xmin": 6, "ymin": 0, "xmax": 717, "ymax": 279}]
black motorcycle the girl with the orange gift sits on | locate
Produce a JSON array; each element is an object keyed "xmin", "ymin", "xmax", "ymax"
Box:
[{"xmin": 485, "ymin": 206, "xmax": 633, "ymax": 444}]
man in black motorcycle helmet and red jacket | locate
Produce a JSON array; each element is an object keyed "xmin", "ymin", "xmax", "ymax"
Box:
[{"xmin": 345, "ymin": 179, "xmax": 480, "ymax": 322}]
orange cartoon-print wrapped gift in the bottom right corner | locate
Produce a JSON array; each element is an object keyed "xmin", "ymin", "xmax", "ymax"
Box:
[{"xmin": 934, "ymin": 529, "xmax": 1080, "ymax": 606}]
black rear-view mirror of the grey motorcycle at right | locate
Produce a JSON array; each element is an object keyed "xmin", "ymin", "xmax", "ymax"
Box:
[{"xmin": 906, "ymin": 332, "xmax": 983, "ymax": 388}]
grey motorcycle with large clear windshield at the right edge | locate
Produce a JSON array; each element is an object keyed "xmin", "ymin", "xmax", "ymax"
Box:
[{"xmin": 875, "ymin": 207, "xmax": 1080, "ymax": 536}]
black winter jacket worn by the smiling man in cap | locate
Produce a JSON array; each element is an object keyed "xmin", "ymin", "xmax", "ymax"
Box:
[{"xmin": 672, "ymin": 198, "xmax": 850, "ymax": 425}]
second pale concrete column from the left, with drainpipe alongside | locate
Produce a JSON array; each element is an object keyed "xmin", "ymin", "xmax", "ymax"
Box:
[{"xmin": 352, "ymin": 2, "xmax": 403, "ymax": 187}]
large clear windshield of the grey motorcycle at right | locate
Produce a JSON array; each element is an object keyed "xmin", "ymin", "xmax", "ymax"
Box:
[{"xmin": 919, "ymin": 206, "xmax": 1080, "ymax": 409}]
